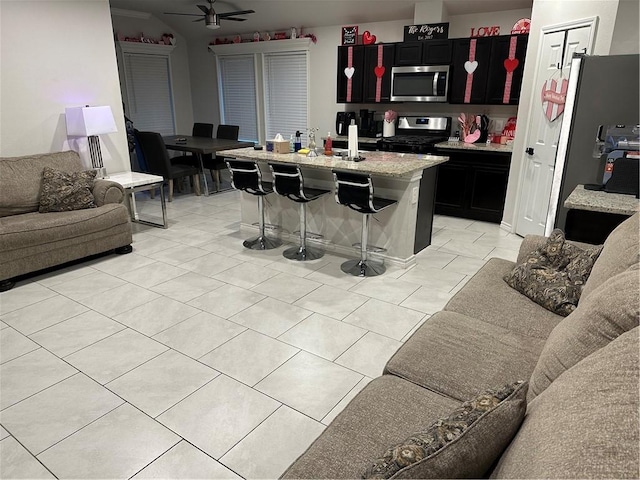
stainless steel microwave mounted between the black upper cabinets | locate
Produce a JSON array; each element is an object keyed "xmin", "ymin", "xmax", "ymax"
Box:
[{"xmin": 391, "ymin": 65, "xmax": 449, "ymax": 102}]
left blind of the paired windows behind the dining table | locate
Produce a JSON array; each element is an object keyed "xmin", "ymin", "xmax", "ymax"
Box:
[{"xmin": 218, "ymin": 55, "xmax": 258, "ymax": 142}]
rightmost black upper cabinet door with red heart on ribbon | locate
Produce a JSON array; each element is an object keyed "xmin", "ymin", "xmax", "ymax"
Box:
[{"xmin": 486, "ymin": 35, "xmax": 529, "ymax": 105}]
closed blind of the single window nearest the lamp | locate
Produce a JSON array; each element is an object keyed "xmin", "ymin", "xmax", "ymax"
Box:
[{"xmin": 124, "ymin": 53, "xmax": 175, "ymax": 135}]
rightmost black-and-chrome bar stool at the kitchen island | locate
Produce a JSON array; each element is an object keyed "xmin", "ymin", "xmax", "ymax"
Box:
[{"xmin": 333, "ymin": 170, "xmax": 398, "ymax": 277}]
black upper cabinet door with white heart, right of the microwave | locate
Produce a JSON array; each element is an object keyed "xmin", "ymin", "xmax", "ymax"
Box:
[{"xmin": 449, "ymin": 37, "xmax": 491, "ymax": 104}]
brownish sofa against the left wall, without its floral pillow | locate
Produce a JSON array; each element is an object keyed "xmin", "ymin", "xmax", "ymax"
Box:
[{"xmin": 0, "ymin": 151, "xmax": 132, "ymax": 291}]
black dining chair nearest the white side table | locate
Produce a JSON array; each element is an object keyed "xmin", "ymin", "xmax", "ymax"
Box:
[{"xmin": 135, "ymin": 132, "xmax": 200, "ymax": 202}]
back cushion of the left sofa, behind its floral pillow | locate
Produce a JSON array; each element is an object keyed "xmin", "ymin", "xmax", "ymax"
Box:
[{"xmin": 0, "ymin": 151, "xmax": 84, "ymax": 217}]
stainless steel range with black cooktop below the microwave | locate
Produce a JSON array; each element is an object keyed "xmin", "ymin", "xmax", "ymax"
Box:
[{"xmin": 379, "ymin": 116, "xmax": 451, "ymax": 153}]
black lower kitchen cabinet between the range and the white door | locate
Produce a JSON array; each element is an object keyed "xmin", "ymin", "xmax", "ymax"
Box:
[{"xmin": 435, "ymin": 149, "xmax": 511, "ymax": 223}]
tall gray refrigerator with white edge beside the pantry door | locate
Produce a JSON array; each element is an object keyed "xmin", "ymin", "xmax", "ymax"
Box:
[{"xmin": 545, "ymin": 54, "xmax": 640, "ymax": 235}]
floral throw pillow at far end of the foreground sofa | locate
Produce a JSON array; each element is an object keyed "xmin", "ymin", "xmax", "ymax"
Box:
[{"xmin": 504, "ymin": 229, "xmax": 602, "ymax": 316}]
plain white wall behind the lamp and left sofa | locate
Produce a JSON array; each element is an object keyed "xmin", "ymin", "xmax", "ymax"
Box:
[{"xmin": 0, "ymin": 0, "xmax": 130, "ymax": 172}]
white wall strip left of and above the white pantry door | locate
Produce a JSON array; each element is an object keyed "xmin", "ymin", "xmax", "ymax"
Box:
[{"xmin": 503, "ymin": 0, "xmax": 624, "ymax": 230}]
